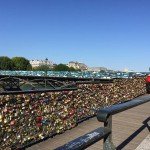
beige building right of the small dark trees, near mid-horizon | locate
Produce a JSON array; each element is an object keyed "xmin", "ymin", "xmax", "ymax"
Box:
[{"xmin": 67, "ymin": 61, "xmax": 88, "ymax": 71}]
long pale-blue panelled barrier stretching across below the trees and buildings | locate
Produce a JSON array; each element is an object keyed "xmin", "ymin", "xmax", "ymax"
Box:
[{"xmin": 0, "ymin": 70, "xmax": 149, "ymax": 79}]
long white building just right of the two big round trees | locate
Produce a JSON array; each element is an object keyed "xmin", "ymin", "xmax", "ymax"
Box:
[{"xmin": 30, "ymin": 59, "xmax": 54, "ymax": 68}]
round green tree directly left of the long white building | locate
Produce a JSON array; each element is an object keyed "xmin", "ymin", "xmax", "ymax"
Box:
[{"xmin": 12, "ymin": 57, "xmax": 32, "ymax": 70}]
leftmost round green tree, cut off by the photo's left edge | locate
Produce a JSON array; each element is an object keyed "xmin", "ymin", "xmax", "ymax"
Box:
[{"xmin": 0, "ymin": 56, "xmax": 13, "ymax": 70}]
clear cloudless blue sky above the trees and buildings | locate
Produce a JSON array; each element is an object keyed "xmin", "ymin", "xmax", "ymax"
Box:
[{"xmin": 0, "ymin": 0, "xmax": 150, "ymax": 71}]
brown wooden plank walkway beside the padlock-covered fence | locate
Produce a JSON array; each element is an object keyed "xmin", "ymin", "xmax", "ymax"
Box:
[{"xmin": 27, "ymin": 99, "xmax": 150, "ymax": 150}]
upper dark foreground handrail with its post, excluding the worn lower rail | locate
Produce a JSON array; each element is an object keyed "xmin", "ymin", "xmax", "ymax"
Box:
[{"xmin": 97, "ymin": 95, "xmax": 150, "ymax": 150}]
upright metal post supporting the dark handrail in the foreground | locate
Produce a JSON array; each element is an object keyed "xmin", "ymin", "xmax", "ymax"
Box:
[{"xmin": 103, "ymin": 115, "xmax": 116, "ymax": 150}]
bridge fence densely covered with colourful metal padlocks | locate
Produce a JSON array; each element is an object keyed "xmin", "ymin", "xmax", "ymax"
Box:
[{"xmin": 0, "ymin": 78, "xmax": 146, "ymax": 149}]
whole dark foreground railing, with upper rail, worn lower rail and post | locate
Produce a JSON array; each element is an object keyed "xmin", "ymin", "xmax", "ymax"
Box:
[{"xmin": 56, "ymin": 95, "xmax": 150, "ymax": 150}]
